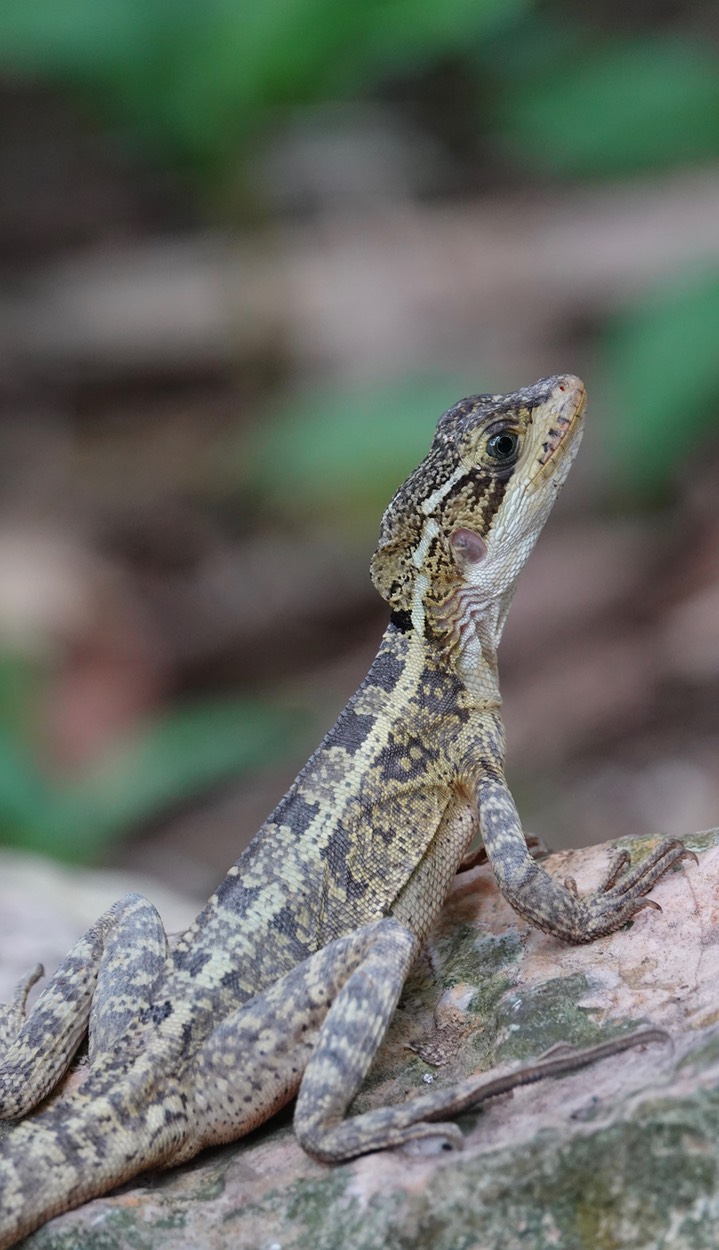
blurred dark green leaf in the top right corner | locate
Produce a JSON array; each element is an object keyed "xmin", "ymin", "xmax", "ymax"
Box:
[{"xmin": 496, "ymin": 29, "xmax": 719, "ymax": 175}]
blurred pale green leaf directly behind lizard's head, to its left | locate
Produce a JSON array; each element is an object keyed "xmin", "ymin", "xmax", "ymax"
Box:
[{"xmin": 240, "ymin": 376, "xmax": 478, "ymax": 534}]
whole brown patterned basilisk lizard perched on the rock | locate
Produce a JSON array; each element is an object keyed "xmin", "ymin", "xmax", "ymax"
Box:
[{"xmin": 0, "ymin": 376, "xmax": 688, "ymax": 1248}]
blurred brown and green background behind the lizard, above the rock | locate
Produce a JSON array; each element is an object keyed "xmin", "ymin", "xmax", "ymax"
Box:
[{"xmin": 0, "ymin": 0, "xmax": 719, "ymax": 893}]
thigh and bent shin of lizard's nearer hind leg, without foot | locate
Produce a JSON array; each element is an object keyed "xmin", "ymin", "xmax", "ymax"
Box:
[{"xmin": 168, "ymin": 919, "xmax": 418, "ymax": 1166}]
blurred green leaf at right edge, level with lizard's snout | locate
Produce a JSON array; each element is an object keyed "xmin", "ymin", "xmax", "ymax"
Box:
[{"xmin": 603, "ymin": 274, "xmax": 719, "ymax": 496}]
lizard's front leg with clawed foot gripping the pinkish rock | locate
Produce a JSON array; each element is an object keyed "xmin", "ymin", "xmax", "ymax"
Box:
[{"xmin": 478, "ymin": 773, "xmax": 696, "ymax": 943}]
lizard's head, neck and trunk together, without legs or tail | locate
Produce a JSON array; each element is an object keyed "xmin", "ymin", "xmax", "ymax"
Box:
[{"xmin": 167, "ymin": 376, "xmax": 584, "ymax": 996}]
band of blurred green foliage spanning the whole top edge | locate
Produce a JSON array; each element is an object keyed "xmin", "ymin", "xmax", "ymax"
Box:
[{"xmin": 0, "ymin": 0, "xmax": 719, "ymax": 183}]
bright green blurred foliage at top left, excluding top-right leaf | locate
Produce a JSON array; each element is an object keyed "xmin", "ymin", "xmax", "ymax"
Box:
[{"xmin": 0, "ymin": 0, "xmax": 526, "ymax": 181}]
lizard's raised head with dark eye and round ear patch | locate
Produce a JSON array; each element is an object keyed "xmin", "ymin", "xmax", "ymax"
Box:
[{"xmin": 371, "ymin": 374, "xmax": 586, "ymax": 646}]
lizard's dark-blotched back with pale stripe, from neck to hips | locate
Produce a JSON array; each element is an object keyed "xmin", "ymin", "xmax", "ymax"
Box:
[{"xmin": 173, "ymin": 624, "xmax": 476, "ymax": 995}]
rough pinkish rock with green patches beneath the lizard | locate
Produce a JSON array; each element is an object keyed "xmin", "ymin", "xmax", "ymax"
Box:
[{"xmin": 0, "ymin": 830, "xmax": 719, "ymax": 1250}]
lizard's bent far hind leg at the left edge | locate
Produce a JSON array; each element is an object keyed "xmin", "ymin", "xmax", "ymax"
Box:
[{"xmin": 0, "ymin": 894, "xmax": 165, "ymax": 1119}]
